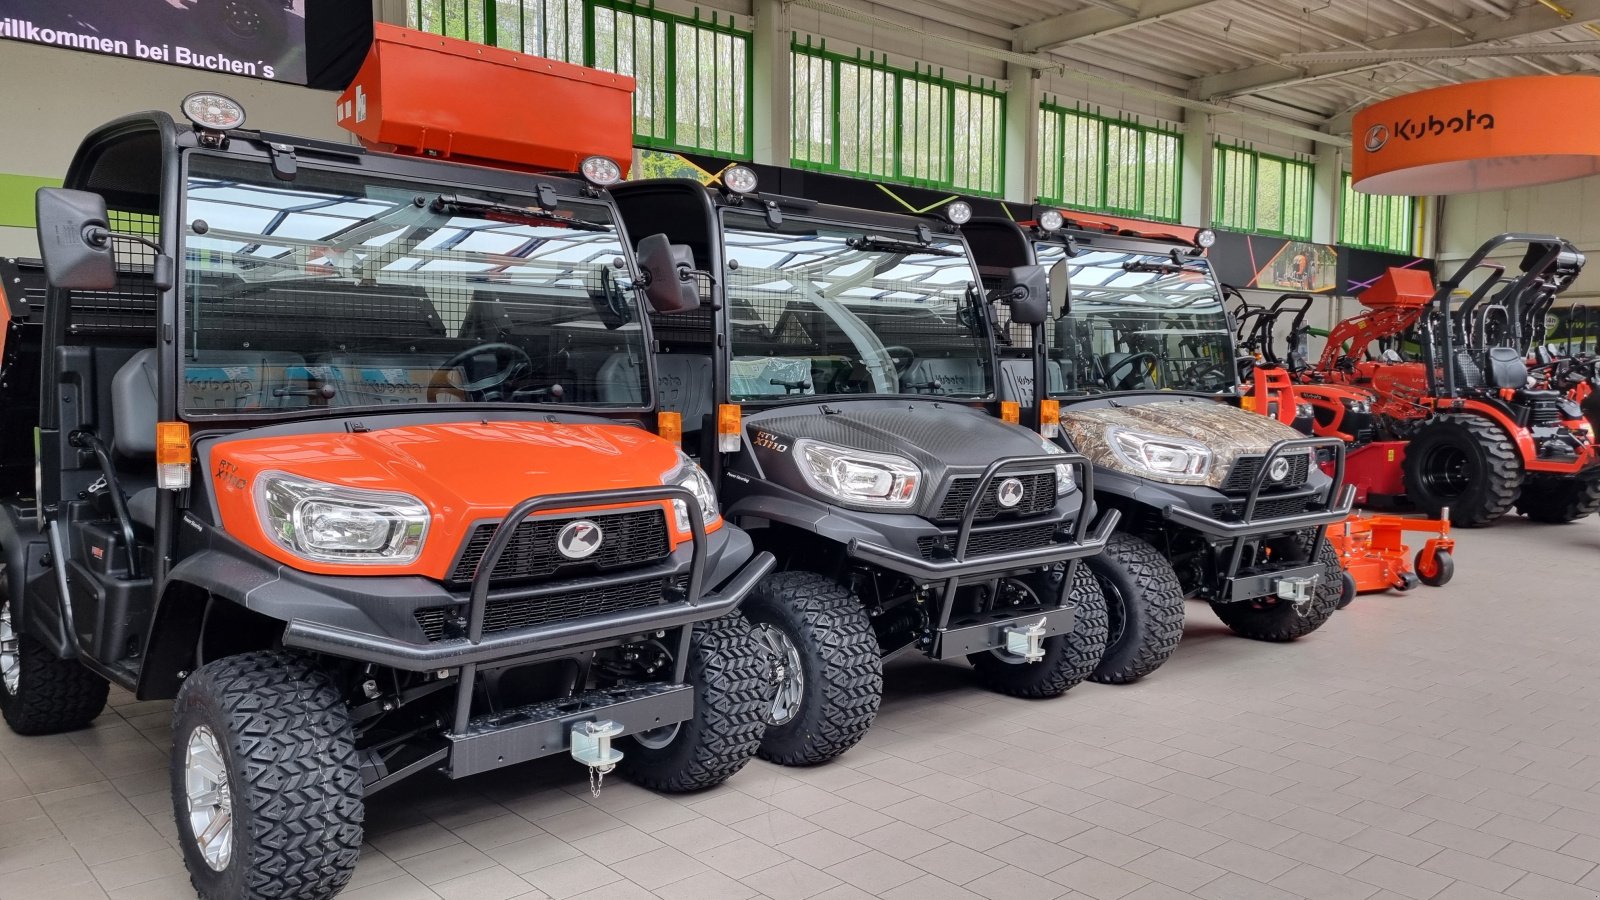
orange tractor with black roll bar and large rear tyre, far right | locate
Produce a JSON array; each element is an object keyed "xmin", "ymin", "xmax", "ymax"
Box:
[{"xmin": 1317, "ymin": 234, "xmax": 1600, "ymax": 527}]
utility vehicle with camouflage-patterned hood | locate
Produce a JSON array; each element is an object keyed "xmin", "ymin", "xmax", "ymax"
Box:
[{"xmin": 963, "ymin": 210, "xmax": 1352, "ymax": 650}]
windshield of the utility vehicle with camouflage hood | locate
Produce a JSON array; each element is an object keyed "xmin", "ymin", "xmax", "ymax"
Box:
[{"xmin": 1037, "ymin": 243, "xmax": 1237, "ymax": 394}]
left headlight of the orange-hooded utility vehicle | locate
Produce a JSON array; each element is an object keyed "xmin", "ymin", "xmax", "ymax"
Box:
[{"xmin": 256, "ymin": 472, "xmax": 429, "ymax": 565}]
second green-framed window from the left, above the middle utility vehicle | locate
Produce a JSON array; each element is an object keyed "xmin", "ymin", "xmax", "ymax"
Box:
[{"xmin": 790, "ymin": 42, "xmax": 1005, "ymax": 197}]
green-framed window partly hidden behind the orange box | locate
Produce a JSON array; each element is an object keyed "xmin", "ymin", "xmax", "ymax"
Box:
[{"xmin": 406, "ymin": 0, "xmax": 750, "ymax": 159}]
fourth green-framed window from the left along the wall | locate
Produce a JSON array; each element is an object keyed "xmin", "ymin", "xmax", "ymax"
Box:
[{"xmin": 1211, "ymin": 144, "xmax": 1312, "ymax": 240}]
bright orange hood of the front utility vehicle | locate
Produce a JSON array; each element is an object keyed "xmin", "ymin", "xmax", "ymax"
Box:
[{"xmin": 208, "ymin": 421, "xmax": 688, "ymax": 578}]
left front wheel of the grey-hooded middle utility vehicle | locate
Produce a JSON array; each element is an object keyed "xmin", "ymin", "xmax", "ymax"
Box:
[{"xmin": 739, "ymin": 570, "xmax": 883, "ymax": 765}]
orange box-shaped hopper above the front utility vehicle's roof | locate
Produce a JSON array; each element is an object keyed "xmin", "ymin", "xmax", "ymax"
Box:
[{"xmin": 338, "ymin": 22, "xmax": 634, "ymax": 176}]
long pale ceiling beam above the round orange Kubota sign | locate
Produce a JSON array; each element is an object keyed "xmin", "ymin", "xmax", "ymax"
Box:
[{"xmin": 1195, "ymin": 0, "xmax": 1600, "ymax": 98}]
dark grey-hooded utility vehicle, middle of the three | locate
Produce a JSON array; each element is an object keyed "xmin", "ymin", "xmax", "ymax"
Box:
[{"xmin": 616, "ymin": 170, "xmax": 1115, "ymax": 764}]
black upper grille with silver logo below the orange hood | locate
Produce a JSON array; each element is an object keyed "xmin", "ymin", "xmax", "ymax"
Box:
[{"xmin": 450, "ymin": 508, "xmax": 670, "ymax": 585}]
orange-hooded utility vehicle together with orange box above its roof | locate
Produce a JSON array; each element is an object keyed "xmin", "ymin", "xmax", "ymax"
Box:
[{"xmin": 0, "ymin": 27, "xmax": 773, "ymax": 900}]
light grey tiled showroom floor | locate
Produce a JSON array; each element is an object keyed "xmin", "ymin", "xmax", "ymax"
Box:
[{"xmin": 9, "ymin": 519, "xmax": 1600, "ymax": 900}]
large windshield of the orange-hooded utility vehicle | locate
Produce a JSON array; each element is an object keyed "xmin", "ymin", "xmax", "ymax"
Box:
[{"xmin": 181, "ymin": 155, "xmax": 650, "ymax": 413}]
